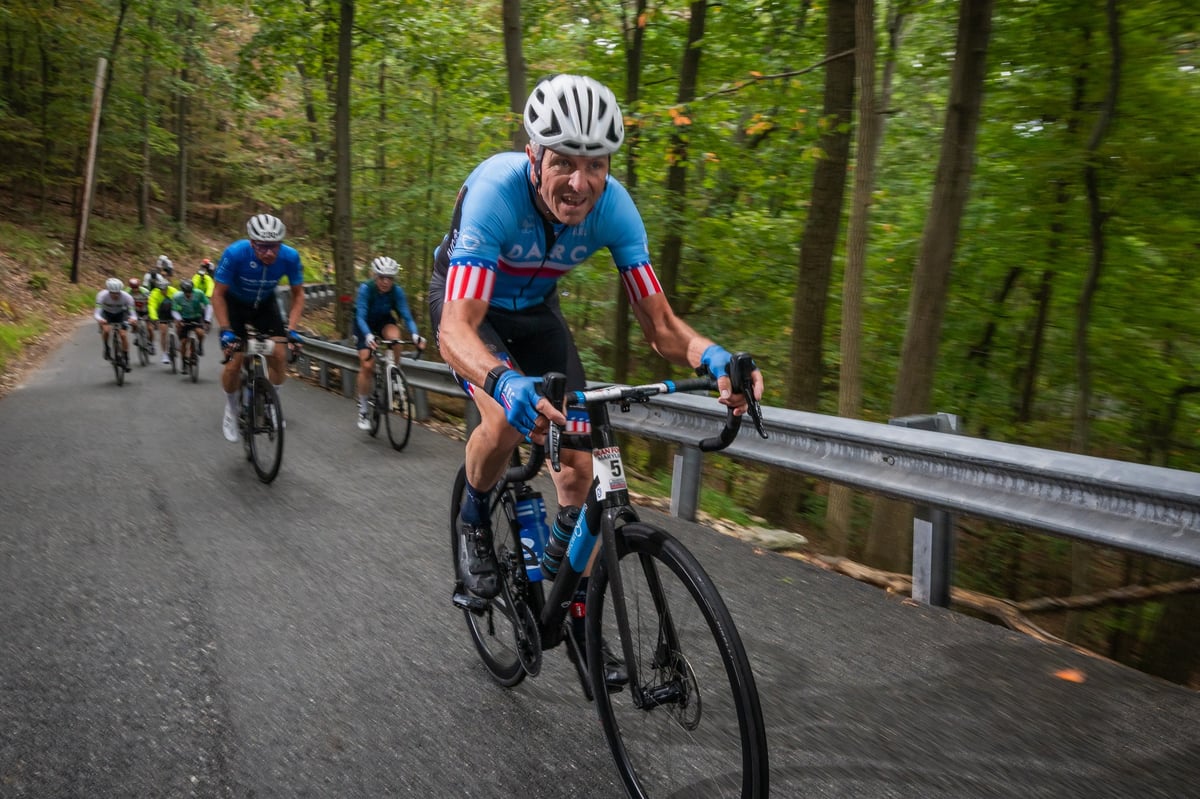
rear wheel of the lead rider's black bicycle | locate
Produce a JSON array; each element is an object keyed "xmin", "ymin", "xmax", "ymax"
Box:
[{"xmin": 450, "ymin": 465, "xmax": 526, "ymax": 687}]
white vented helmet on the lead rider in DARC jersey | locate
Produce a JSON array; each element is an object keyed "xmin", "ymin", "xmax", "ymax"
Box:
[{"xmin": 524, "ymin": 74, "xmax": 625, "ymax": 156}]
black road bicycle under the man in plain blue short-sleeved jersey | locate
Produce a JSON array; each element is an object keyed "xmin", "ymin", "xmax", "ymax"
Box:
[{"xmin": 222, "ymin": 329, "xmax": 296, "ymax": 482}]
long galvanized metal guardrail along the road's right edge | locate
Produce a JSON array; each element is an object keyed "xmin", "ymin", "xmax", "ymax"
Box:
[{"xmin": 290, "ymin": 340, "xmax": 1200, "ymax": 599}]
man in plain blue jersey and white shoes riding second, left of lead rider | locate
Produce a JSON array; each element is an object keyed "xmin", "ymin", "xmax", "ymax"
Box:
[{"xmin": 212, "ymin": 214, "xmax": 304, "ymax": 441}]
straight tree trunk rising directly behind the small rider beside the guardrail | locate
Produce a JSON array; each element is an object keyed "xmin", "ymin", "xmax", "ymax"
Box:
[{"xmin": 334, "ymin": 0, "xmax": 354, "ymax": 336}]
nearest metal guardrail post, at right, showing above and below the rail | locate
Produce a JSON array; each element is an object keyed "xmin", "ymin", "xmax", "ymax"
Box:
[{"xmin": 888, "ymin": 414, "xmax": 959, "ymax": 607}]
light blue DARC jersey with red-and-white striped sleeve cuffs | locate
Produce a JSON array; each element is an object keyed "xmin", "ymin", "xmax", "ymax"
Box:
[{"xmin": 430, "ymin": 152, "xmax": 662, "ymax": 311}]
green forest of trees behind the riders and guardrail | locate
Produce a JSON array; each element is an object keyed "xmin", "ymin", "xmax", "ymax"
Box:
[{"xmin": 0, "ymin": 0, "xmax": 1200, "ymax": 687}]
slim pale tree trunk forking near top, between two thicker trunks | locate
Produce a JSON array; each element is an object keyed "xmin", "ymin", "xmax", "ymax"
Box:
[{"xmin": 826, "ymin": 0, "xmax": 904, "ymax": 547}]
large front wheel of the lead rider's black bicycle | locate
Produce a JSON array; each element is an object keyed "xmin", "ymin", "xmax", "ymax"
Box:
[{"xmin": 586, "ymin": 522, "xmax": 769, "ymax": 799}]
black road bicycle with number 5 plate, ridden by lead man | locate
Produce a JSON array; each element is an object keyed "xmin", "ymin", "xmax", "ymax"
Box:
[{"xmin": 450, "ymin": 353, "xmax": 769, "ymax": 799}]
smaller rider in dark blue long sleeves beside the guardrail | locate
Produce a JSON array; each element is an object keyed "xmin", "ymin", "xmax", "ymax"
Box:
[{"xmin": 354, "ymin": 256, "xmax": 425, "ymax": 429}]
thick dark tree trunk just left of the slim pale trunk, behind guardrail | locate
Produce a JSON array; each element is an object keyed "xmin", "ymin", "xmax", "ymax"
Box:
[{"xmin": 760, "ymin": 0, "xmax": 856, "ymax": 527}]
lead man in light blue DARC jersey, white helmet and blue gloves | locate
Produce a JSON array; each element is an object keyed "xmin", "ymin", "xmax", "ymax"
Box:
[{"xmin": 430, "ymin": 74, "xmax": 763, "ymax": 609}]
